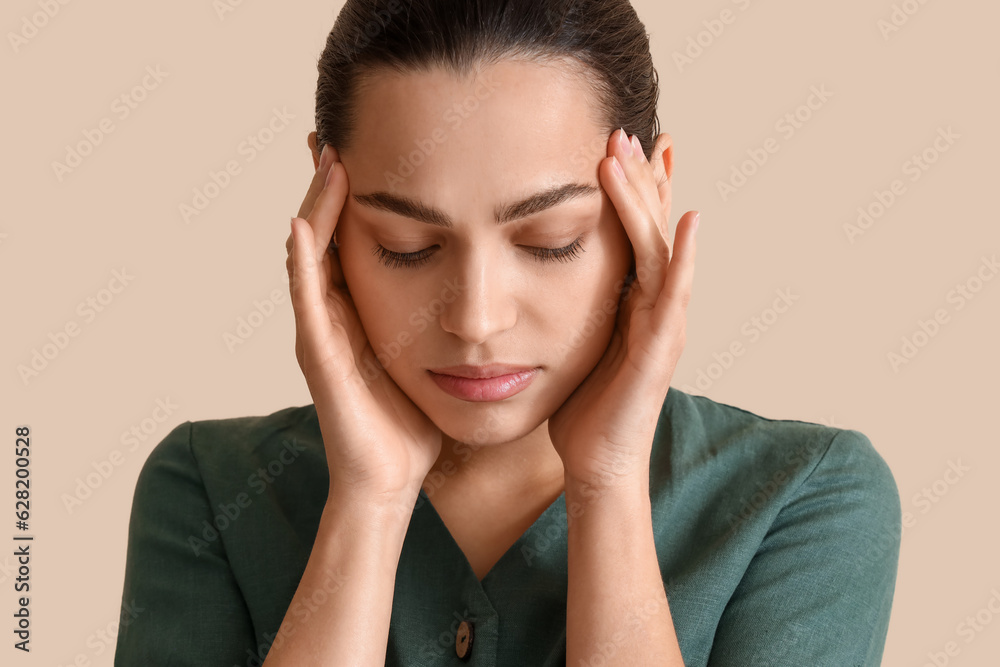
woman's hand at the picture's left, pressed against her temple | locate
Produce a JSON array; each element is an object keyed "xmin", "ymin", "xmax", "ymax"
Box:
[{"xmin": 286, "ymin": 145, "xmax": 441, "ymax": 509}]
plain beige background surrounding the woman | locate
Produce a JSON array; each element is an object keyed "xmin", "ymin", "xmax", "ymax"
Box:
[{"xmin": 0, "ymin": 0, "xmax": 1000, "ymax": 666}]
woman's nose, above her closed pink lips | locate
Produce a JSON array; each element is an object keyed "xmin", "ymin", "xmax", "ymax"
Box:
[{"xmin": 439, "ymin": 249, "xmax": 517, "ymax": 345}]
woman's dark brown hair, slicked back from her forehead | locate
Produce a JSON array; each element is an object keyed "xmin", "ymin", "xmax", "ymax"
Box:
[{"xmin": 316, "ymin": 0, "xmax": 659, "ymax": 159}]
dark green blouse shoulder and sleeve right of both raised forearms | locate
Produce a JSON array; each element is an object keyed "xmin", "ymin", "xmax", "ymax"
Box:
[{"xmin": 650, "ymin": 400, "xmax": 901, "ymax": 665}]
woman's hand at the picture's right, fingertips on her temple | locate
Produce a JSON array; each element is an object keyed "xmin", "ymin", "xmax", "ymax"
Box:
[{"xmin": 549, "ymin": 130, "xmax": 698, "ymax": 490}]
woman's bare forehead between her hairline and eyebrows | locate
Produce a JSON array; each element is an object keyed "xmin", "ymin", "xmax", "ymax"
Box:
[{"xmin": 349, "ymin": 60, "xmax": 610, "ymax": 162}]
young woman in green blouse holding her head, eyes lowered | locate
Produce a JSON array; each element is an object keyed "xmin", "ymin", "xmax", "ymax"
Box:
[{"xmin": 115, "ymin": 0, "xmax": 900, "ymax": 667}]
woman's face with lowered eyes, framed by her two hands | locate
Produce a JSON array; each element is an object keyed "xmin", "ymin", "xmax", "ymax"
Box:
[{"xmin": 337, "ymin": 56, "xmax": 632, "ymax": 445}]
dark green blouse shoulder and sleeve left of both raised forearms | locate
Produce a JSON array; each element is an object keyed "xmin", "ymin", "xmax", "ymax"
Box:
[{"xmin": 119, "ymin": 405, "xmax": 329, "ymax": 664}]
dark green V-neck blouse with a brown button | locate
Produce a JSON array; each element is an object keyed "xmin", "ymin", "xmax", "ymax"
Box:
[{"xmin": 114, "ymin": 387, "xmax": 901, "ymax": 667}]
